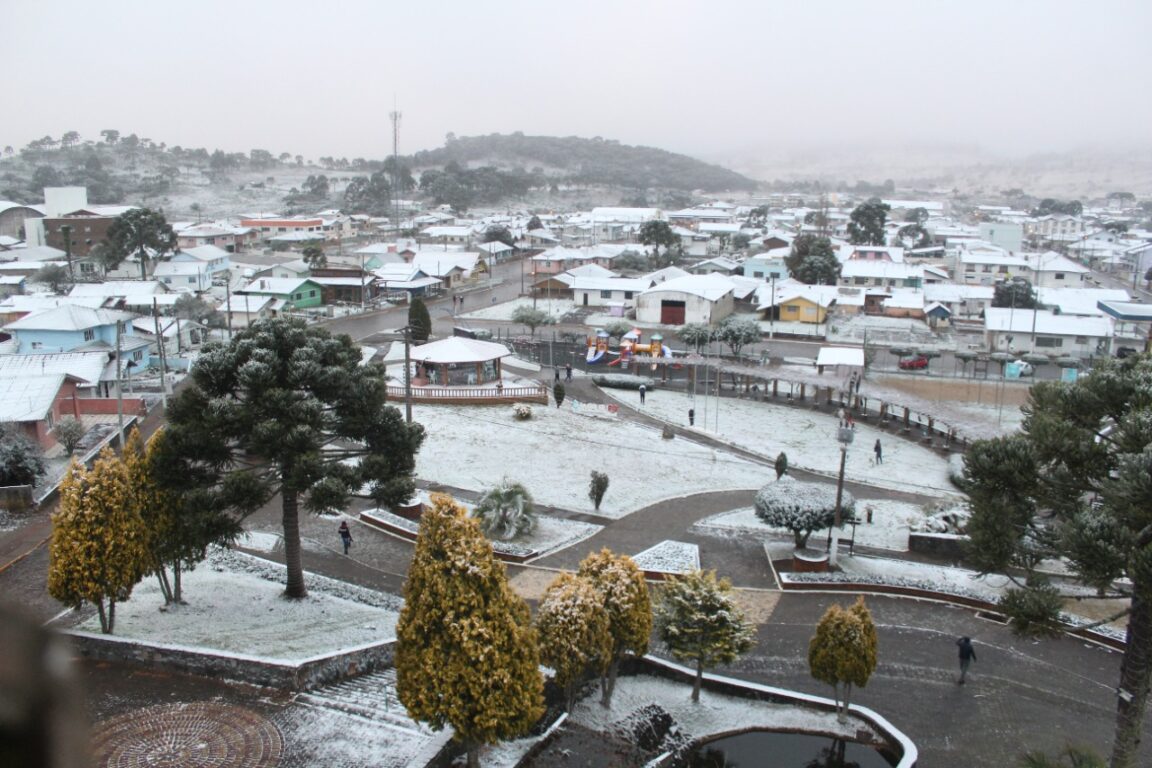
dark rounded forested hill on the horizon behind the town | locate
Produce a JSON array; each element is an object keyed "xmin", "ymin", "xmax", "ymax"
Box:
[{"xmin": 411, "ymin": 132, "xmax": 757, "ymax": 192}]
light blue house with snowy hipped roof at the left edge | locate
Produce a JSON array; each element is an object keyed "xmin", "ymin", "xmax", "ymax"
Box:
[{"xmin": 2, "ymin": 304, "xmax": 151, "ymax": 370}]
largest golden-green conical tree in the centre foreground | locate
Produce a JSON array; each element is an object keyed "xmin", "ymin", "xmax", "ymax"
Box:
[{"xmin": 396, "ymin": 494, "xmax": 544, "ymax": 767}]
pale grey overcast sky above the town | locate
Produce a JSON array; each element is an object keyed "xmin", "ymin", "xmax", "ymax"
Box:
[{"xmin": 0, "ymin": 0, "xmax": 1152, "ymax": 159}]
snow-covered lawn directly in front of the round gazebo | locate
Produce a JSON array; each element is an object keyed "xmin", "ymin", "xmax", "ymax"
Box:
[{"xmin": 412, "ymin": 401, "xmax": 771, "ymax": 519}]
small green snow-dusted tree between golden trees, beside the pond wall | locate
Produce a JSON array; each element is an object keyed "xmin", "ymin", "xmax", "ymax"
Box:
[{"xmin": 655, "ymin": 571, "xmax": 756, "ymax": 701}]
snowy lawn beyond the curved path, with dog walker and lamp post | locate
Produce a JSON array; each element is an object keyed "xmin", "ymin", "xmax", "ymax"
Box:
[{"xmin": 602, "ymin": 388, "xmax": 960, "ymax": 495}]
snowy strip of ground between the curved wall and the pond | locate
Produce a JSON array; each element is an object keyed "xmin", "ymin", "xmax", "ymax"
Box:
[{"xmin": 571, "ymin": 675, "xmax": 871, "ymax": 738}]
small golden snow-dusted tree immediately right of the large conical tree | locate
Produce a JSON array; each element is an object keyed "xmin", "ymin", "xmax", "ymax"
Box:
[{"xmin": 536, "ymin": 573, "xmax": 612, "ymax": 712}]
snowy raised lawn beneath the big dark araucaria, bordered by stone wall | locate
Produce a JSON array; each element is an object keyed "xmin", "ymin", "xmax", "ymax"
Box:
[{"xmin": 77, "ymin": 553, "xmax": 400, "ymax": 662}]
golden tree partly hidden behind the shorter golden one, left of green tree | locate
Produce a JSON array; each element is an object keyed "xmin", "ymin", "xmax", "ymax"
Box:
[{"xmin": 577, "ymin": 549, "xmax": 652, "ymax": 708}]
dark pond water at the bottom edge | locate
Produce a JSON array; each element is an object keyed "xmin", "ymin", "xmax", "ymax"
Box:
[{"xmin": 675, "ymin": 731, "xmax": 897, "ymax": 768}]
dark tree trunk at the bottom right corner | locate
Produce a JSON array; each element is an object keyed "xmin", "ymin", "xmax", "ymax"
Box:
[{"xmin": 1108, "ymin": 584, "xmax": 1152, "ymax": 768}]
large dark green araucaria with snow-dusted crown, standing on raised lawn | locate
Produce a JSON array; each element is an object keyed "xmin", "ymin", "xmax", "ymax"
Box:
[{"xmin": 155, "ymin": 318, "xmax": 424, "ymax": 598}]
